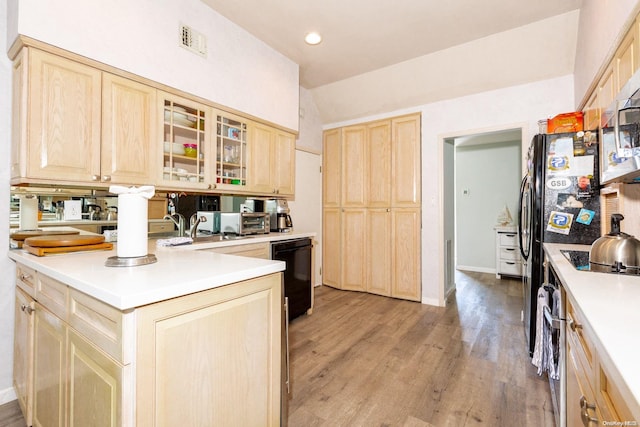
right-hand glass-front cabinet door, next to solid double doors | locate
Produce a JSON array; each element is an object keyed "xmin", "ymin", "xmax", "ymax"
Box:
[{"xmin": 215, "ymin": 111, "xmax": 247, "ymax": 191}]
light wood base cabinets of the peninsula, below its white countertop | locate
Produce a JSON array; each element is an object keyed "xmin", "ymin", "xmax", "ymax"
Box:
[{"xmin": 14, "ymin": 268, "xmax": 282, "ymax": 426}]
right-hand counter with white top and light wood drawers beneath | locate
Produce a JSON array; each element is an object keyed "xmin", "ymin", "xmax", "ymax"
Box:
[{"xmin": 544, "ymin": 243, "xmax": 640, "ymax": 425}]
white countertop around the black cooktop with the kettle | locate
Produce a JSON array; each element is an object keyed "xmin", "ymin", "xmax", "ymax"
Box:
[{"xmin": 544, "ymin": 243, "xmax": 640, "ymax": 420}]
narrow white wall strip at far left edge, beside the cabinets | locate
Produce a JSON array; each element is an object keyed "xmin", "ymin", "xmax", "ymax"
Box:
[{"xmin": 0, "ymin": 0, "xmax": 16, "ymax": 405}]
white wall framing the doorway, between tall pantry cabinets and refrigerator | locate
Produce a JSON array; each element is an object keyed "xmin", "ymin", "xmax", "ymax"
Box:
[{"xmin": 420, "ymin": 76, "xmax": 573, "ymax": 305}]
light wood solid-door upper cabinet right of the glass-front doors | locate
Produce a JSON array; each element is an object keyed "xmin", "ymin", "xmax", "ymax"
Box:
[{"xmin": 248, "ymin": 122, "xmax": 296, "ymax": 196}]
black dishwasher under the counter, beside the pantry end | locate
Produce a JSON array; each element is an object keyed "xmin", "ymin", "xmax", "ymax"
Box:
[{"xmin": 271, "ymin": 239, "xmax": 311, "ymax": 320}]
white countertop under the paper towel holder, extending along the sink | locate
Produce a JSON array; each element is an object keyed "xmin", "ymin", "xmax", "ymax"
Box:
[{"xmin": 9, "ymin": 233, "xmax": 315, "ymax": 310}]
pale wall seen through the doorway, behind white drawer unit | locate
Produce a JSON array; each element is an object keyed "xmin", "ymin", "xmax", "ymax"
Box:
[{"xmin": 442, "ymin": 127, "xmax": 522, "ymax": 300}]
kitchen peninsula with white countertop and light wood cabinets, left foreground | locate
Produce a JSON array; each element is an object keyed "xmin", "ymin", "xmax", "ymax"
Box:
[{"xmin": 9, "ymin": 241, "xmax": 285, "ymax": 426}]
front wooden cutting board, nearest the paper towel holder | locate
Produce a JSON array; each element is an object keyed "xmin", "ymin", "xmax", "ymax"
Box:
[{"xmin": 22, "ymin": 234, "xmax": 113, "ymax": 256}]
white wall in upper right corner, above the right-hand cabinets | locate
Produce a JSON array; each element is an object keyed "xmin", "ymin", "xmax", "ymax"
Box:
[{"xmin": 574, "ymin": 0, "xmax": 640, "ymax": 105}]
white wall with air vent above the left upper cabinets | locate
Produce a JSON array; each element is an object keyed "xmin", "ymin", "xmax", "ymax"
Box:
[{"xmin": 8, "ymin": 0, "xmax": 299, "ymax": 130}]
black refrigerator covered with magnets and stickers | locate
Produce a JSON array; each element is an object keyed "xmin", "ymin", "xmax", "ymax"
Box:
[{"xmin": 518, "ymin": 132, "xmax": 600, "ymax": 356}]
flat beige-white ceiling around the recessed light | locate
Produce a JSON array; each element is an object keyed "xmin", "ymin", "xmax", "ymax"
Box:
[{"xmin": 202, "ymin": 0, "xmax": 582, "ymax": 89}]
